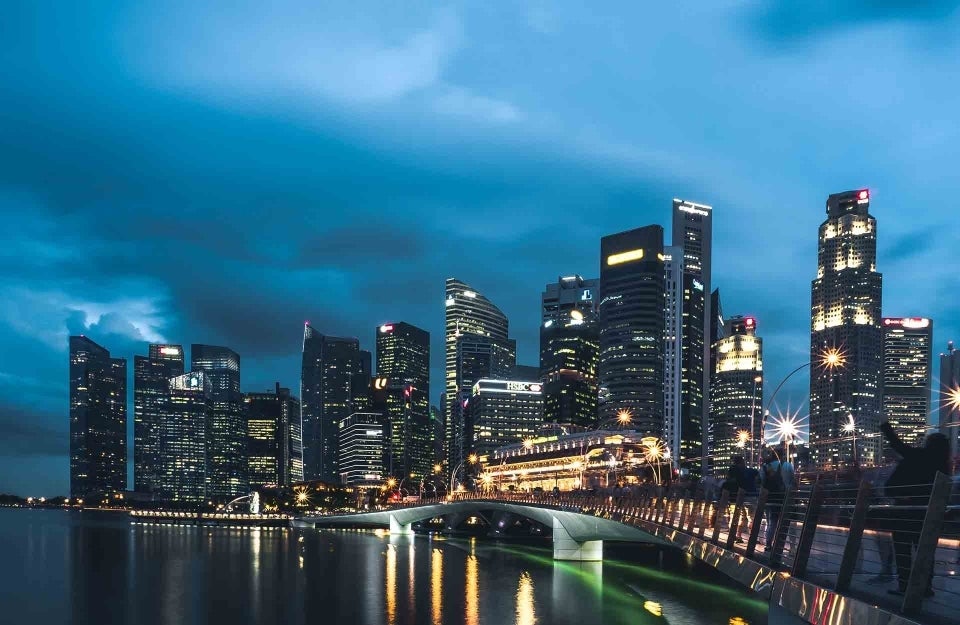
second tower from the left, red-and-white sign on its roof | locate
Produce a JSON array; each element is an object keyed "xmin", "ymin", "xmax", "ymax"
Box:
[{"xmin": 133, "ymin": 344, "xmax": 183, "ymax": 493}]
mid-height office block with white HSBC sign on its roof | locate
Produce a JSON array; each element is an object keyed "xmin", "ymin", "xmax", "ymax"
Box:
[{"xmin": 464, "ymin": 379, "xmax": 543, "ymax": 455}]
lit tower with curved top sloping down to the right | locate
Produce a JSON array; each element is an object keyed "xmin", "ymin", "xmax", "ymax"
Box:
[{"xmin": 443, "ymin": 278, "xmax": 516, "ymax": 471}]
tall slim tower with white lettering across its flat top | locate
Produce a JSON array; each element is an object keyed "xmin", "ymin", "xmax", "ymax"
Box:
[{"xmin": 673, "ymin": 199, "xmax": 713, "ymax": 475}]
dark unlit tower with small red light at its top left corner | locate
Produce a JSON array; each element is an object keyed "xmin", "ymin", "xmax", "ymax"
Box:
[{"xmin": 300, "ymin": 323, "xmax": 370, "ymax": 484}]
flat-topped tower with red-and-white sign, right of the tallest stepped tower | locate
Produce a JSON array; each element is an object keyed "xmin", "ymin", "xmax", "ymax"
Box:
[{"xmin": 883, "ymin": 317, "xmax": 933, "ymax": 446}]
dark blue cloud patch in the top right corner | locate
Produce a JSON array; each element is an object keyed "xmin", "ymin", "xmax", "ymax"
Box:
[{"xmin": 746, "ymin": 0, "xmax": 960, "ymax": 41}]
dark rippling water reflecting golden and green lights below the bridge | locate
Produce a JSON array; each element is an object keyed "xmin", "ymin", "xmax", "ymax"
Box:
[{"xmin": 0, "ymin": 508, "xmax": 766, "ymax": 625}]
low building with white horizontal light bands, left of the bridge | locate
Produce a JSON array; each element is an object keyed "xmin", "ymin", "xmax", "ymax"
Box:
[{"xmin": 338, "ymin": 412, "xmax": 387, "ymax": 487}]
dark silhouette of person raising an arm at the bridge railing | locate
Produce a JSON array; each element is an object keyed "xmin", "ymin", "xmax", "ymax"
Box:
[{"xmin": 880, "ymin": 421, "xmax": 950, "ymax": 597}]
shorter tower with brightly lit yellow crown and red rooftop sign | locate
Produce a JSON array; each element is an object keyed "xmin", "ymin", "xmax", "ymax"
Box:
[{"xmin": 709, "ymin": 317, "xmax": 763, "ymax": 476}]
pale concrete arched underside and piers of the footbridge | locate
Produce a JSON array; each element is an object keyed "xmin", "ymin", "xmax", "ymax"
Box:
[{"xmin": 301, "ymin": 499, "xmax": 672, "ymax": 562}]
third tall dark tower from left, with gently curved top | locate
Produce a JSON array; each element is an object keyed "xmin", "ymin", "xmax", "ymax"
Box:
[{"xmin": 190, "ymin": 343, "xmax": 249, "ymax": 500}]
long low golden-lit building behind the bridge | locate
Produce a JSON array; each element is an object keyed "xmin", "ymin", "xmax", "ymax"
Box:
[{"xmin": 480, "ymin": 430, "xmax": 672, "ymax": 492}]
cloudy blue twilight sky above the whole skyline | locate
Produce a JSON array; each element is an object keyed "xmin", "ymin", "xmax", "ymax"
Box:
[{"xmin": 0, "ymin": 0, "xmax": 960, "ymax": 496}]
